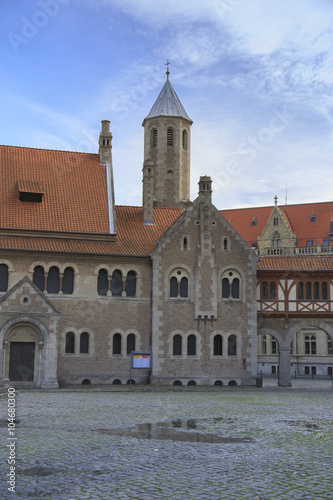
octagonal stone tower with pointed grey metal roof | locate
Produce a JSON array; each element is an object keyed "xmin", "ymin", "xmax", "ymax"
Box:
[{"xmin": 142, "ymin": 68, "xmax": 193, "ymax": 222}]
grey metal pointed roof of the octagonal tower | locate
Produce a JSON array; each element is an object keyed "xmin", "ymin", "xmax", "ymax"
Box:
[{"xmin": 144, "ymin": 71, "xmax": 193, "ymax": 123}]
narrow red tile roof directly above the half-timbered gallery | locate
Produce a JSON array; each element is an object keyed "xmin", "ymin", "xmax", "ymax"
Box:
[{"xmin": 257, "ymin": 255, "xmax": 333, "ymax": 271}]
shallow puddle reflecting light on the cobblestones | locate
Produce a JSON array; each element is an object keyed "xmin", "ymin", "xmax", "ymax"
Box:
[{"xmin": 96, "ymin": 419, "xmax": 255, "ymax": 444}]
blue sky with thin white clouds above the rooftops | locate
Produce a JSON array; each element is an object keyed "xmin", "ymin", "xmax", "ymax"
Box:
[{"xmin": 0, "ymin": 0, "xmax": 333, "ymax": 209}]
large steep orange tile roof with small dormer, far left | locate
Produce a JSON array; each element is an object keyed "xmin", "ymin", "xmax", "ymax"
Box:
[{"xmin": 0, "ymin": 146, "xmax": 109, "ymax": 233}]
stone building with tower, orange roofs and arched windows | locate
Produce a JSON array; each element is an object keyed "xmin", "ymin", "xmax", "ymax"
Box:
[{"xmin": 0, "ymin": 73, "xmax": 257, "ymax": 388}]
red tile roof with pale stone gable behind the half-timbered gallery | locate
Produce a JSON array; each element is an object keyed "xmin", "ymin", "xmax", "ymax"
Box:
[{"xmin": 221, "ymin": 201, "xmax": 333, "ymax": 247}]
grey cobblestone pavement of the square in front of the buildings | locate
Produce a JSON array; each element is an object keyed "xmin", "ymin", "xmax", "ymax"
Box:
[{"xmin": 0, "ymin": 381, "xmax": 333, "ymax": 500}]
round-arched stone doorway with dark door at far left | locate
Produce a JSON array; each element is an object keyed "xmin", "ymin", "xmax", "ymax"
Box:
[{"xmin": 3, "ymin": 322, "xmax": 44, "ymax": 387}]
